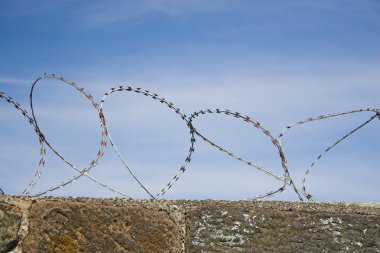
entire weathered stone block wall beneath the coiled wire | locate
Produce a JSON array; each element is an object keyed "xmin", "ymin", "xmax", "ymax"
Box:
[{"xmin": 0, "ymin": 196, "xmax": 380, "ymax": 253}]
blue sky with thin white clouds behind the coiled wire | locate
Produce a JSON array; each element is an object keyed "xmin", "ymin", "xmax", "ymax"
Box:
[{"xmin": 0, "ymin": 0, "xmax": 380, "ymax": 201}]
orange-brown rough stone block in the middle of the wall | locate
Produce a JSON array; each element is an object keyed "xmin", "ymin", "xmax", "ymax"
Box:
[{"xmin": 22, "ymin": 201, "xmax": 181, "ymax": 253}]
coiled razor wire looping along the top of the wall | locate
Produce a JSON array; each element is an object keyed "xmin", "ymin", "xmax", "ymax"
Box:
[{"xmin": 0, "ymin": 74, "xmax": 380, "ymax": 201}]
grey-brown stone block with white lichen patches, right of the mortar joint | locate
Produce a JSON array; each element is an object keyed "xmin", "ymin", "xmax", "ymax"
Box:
[{"xmin": 186, "ymin": 202, "xmax": 380, "ymax": 253}]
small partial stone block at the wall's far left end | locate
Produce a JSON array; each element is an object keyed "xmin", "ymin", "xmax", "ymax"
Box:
[{"xmin": 0, "ymin": 200, "xmax": 22, "ymax": 253}]
